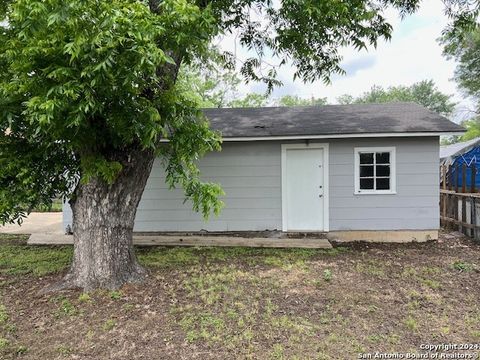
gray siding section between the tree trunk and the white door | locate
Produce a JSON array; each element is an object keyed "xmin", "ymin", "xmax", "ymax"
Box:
[{"xmin": 135, "ymin": 142, "xmax": 282, "ymax": 231}]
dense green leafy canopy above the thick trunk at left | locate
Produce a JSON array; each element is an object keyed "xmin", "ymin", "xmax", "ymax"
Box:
[{"xmin": 0, "ymin": 0, "xmax": 225, "ymax": 222}]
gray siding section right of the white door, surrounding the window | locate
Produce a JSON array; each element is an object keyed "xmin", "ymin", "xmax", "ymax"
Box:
[{"xmin": 330, "ymin": 137, "xmax": 439, "ymax": 230}]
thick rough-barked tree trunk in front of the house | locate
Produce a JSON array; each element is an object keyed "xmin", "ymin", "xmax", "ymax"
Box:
[{"xmin": 62, "ymin": 150, "xmax": 154, "ymax": 291}]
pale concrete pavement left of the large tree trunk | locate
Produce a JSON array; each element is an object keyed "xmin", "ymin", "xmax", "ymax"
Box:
[{"xmin": 0, "ymin": 212, "xmax": 63, "ymax": 235}]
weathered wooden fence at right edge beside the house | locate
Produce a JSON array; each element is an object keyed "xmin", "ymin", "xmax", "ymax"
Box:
[{"xmin": 440, "ymin": 164, "xmax": 480, "ymax": 241}]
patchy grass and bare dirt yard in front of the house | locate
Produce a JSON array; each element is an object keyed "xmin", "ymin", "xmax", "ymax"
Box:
[{"xmin": 0, "ymin": 235, "xmax": 480, "ymax": 360}]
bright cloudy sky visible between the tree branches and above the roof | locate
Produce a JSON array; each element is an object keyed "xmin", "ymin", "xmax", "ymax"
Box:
[{"xmin": 220, "ymin": 0, "xmax": 471, "ymax": 121}]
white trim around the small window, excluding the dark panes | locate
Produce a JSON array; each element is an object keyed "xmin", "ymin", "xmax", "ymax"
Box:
[{"xmin": 354, "ymin": 146, "xmax": 397, "ymax": 195}]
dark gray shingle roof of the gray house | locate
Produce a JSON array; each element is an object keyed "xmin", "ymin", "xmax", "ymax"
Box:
[{"xmin": 204, "ymin": 103, "xmax": 464, "ymax": 138}]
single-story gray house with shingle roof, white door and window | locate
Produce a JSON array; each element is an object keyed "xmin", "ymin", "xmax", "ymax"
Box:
[{"xmin": 64, "ymin": 103, "xmax": 464, "ymax": 241}]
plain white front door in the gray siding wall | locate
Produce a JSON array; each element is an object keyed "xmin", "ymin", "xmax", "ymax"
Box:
[{"xmin": 282, "ymin": 145, "xmax": 327, "ymax": 231}]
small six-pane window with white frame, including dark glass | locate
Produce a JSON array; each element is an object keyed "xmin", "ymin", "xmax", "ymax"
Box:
[{"xmin": 355, "ymin": 147, "xmax": 396, "ymax": 194}]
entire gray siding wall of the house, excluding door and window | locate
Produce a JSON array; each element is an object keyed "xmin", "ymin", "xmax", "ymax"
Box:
[{"xmin": 64, "ymin": 137, "xmax": 439, "ymax": 232}]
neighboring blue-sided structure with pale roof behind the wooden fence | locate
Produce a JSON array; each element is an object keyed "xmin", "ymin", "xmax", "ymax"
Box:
[{"xmin": 440, "ymin": 137, "xmax": 480, "ymax": 188}]
